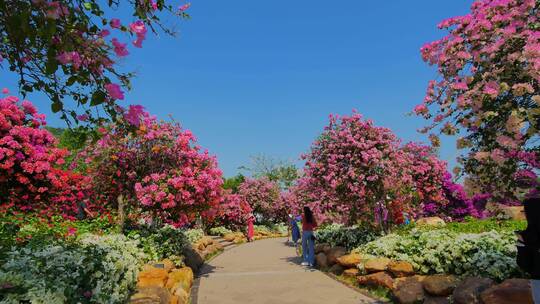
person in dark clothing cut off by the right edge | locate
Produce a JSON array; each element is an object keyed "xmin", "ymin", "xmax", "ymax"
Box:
[{"xmin": 517, "ymin": 197, "xmax": 540, "ymax": 280}]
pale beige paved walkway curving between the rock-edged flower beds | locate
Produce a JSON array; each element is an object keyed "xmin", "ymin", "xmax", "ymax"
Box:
[{"xmin": 193, "ymin": 238, "xmax": 377, "ymax": 304}]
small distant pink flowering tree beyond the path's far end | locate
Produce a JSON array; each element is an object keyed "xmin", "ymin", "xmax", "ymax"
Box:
[{"xmin": 238, "ymin": 177, "xmax": 281, "ymax": 220}]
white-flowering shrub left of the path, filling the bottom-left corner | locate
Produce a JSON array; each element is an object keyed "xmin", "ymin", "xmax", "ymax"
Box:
[{"xmin": 0, "ymin": 234, "xmax": 147, "ymax": 304}]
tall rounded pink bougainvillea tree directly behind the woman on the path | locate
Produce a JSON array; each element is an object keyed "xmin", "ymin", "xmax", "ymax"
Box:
[{"xmin": 303, "ymin": 113, "xmax": 410, "ymax": 227}]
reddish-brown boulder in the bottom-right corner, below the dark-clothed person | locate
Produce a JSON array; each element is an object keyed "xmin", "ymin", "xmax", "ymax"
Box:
[{"xmin": 480, "ymin": 279, "xmax": 534, "ymax": 304}]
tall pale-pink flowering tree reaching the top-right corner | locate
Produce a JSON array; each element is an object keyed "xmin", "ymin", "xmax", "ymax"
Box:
[{"xmin": 414, "ymin": 0, "xmax": 540, "ymax": 199}]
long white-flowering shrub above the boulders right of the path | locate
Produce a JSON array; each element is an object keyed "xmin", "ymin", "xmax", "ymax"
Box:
[{"xmin": 355, "ymin": 229, "xmax": 519, "ymax": 280}]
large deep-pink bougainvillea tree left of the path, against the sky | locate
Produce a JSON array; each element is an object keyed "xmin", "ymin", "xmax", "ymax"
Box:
[{"xmin": 80, "ymin": 106, "xmax": 223, "ymax": 225}]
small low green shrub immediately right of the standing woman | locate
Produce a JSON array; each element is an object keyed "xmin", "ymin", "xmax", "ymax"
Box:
[{"xmin": 315, "ymin": 224, "xmax": 380, "ymax": 250}]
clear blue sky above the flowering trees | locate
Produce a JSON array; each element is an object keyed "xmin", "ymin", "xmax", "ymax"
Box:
[{"xmin": 0, "ymin": 0, "xmax": 472, "ymax": 176}]
